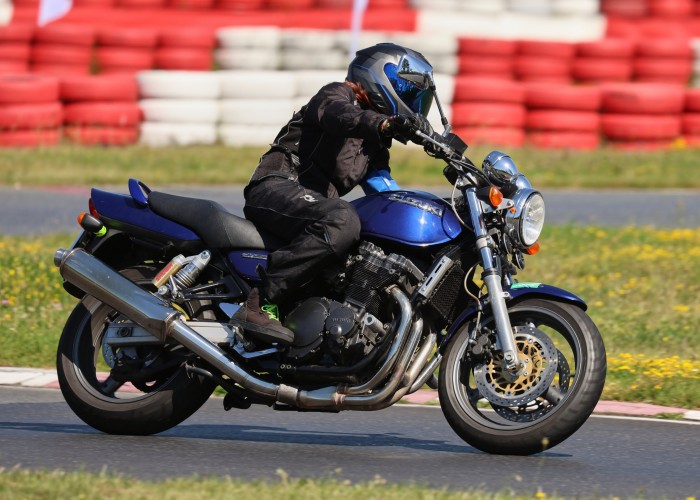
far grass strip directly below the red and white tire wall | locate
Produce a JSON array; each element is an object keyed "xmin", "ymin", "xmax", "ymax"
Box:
[{"xmin": 0, "ymin": 144, "xmax": 700, "ymax": 189}]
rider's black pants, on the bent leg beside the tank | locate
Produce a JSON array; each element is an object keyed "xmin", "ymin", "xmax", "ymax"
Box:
[{"xmin": 243, "ymin": 177, "xmax": 360, "ymax": 304}]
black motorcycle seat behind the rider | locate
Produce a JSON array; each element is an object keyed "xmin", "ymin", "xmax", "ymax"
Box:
[{"xmin": 148, "ymin": 191, "xmax": 284, "ymax": 250}]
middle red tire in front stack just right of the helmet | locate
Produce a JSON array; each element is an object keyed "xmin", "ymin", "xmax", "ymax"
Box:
[{"xmin": 452, "ymin": 102, "xmax": 525, "ymax": 128}]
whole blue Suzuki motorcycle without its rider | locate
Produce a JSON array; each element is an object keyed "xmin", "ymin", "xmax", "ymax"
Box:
[{"xmin": 55, "ymin": 116, "xmax": 606, "ymax": 455}]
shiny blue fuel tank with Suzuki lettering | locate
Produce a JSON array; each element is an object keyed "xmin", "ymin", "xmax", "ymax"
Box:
[{"xmin": 351, "ymin": 191, "xmax": 462, "ymax": 247}]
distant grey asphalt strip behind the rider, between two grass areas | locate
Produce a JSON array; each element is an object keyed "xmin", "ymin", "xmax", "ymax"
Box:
[{"xmin": 0, "ymin": 184, "xmax": 700, "ymax": 235}]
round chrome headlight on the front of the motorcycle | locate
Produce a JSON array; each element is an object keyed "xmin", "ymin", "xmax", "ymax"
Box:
[{"xmin": 506, "ymin": 188, "xmax": 545, "ymax": 250}]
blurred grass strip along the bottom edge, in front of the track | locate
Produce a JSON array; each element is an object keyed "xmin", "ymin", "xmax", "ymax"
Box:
[{"xmin": 0, "ymin": 469, "xmax": 584, "ymax": 500}]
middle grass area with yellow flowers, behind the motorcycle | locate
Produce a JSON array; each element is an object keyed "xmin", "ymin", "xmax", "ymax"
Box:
[{"xmin": 0, "ymin": 226, "xmax": 700, "ymax": 408}]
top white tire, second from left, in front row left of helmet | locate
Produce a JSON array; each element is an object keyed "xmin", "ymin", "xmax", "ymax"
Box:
[{"xmin": 219, "ymin": 70, "xmax": 296, "ymax": 99}]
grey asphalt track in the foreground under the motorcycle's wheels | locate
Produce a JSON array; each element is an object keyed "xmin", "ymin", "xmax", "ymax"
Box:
[{"xmin": 0, "ymin": 387, "xmax": 700, "ymax": 499}]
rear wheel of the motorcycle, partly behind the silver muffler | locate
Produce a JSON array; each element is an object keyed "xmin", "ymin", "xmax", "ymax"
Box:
[{"xmin": 57, "ymin": 267, "xmax": 216, "ymax": 435}]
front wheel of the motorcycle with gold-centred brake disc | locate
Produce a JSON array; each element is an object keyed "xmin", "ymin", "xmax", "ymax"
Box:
[{"xmin": 438, "ymin": 299, "xmax": 606, "ymax": 455}]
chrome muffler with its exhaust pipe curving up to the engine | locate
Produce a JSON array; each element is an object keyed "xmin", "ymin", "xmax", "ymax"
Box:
[{"xmin": 54, "ymin": 248, "xmax": 416, "ymax": 410}]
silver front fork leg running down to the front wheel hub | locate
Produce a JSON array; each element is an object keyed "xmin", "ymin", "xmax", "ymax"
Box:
[{"xmin": 464, "ymin": 187, "xmax": 520, "ymax": 371}]
